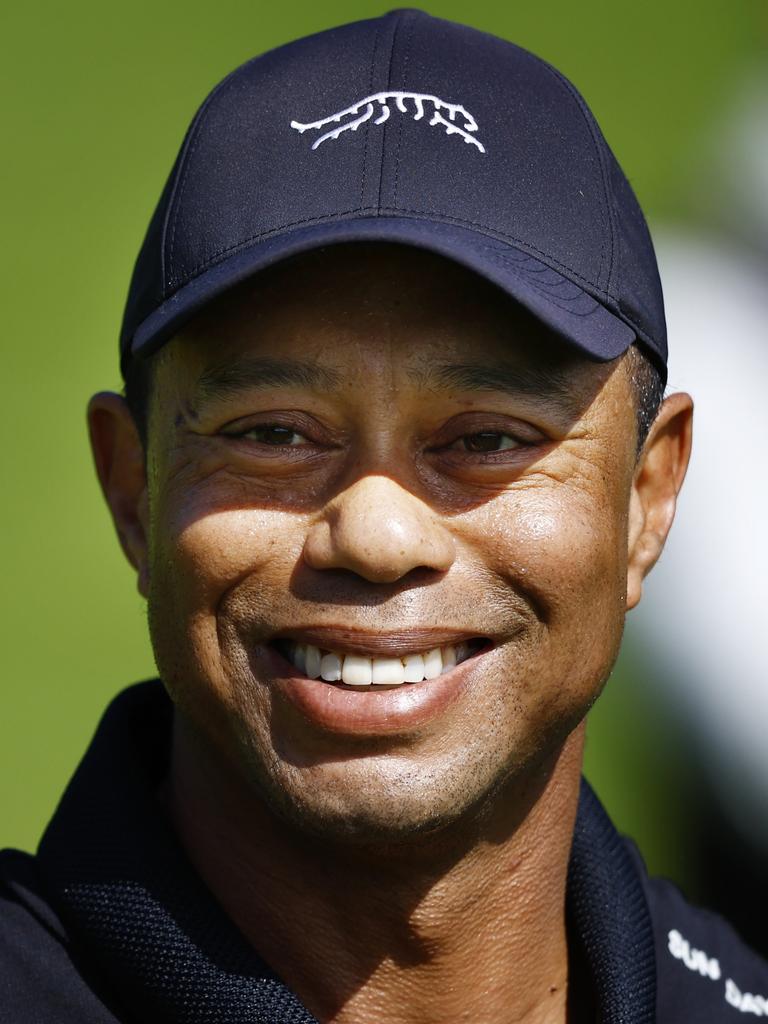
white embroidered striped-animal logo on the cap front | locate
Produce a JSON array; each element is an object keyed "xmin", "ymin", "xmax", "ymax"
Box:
[{"xmin": 291, "ymin": 92, "xmax": 485, "ymax": 153}]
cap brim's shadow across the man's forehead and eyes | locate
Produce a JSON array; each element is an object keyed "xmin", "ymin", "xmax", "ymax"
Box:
[{"xmin": 152, "ymin": 244, "xmax": 632, "ymax": 517}]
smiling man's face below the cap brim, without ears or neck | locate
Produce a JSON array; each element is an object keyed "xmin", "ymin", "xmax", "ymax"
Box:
[{"xmin": 137, "ymin": 246, "xmax": 635, "ymax": 839}]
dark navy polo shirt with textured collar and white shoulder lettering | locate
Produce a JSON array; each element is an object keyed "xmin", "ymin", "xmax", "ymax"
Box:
[{"xmin": 0, "ymin": 682, "xmax": 768, "ymax": 1024}]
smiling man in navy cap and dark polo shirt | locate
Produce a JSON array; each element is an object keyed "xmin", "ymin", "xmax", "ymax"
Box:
[{"xmin": 0, "ymin": 11, "xmax": 768, "ymax": 1024}]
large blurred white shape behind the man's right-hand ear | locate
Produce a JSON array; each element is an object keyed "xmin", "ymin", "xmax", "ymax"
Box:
[{"xmin": 628, "ymin": 232, "xmax": 768, "ymax": 851}]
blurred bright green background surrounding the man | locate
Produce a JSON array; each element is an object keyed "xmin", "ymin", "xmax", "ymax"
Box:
[{"xmin": 0, "ymin": 0, "xmax": 768, "ymax": 891}]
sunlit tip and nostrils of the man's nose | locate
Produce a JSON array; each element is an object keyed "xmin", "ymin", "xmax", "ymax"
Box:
[{"xmin": 304, "ymin": 476, "xmax": 456, "ymax": 583}]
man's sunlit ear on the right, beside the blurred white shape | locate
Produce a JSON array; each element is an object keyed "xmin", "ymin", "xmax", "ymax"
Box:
[{"xmin": 627, "ymin": 392, "xmax": 693, "ymax": 608}]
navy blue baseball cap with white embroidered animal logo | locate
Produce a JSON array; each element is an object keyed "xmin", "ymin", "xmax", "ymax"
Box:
[{"xmin": 121, "ymin": 10, "xmax": 667, "ymax": 374}]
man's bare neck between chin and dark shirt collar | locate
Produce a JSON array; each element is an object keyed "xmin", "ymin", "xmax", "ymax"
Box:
[{"xmin": 168, "ymin": 729, "xmax": 583, "ymax": 1024}]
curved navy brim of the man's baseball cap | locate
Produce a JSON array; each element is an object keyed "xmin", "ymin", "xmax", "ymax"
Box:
[{"xmin": 124, "ymin": 216, "xmax": 637, "ymax": 360}]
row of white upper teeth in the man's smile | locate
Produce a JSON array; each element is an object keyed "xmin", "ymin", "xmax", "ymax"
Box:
[{"xmin": 286, "ymin": 642, "xmax": 471, "ymax": 686}]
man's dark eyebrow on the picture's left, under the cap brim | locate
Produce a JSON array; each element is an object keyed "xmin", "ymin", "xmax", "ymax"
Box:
[{"xmin": 194, "ymin": 356, "xmax": 341, "ymax": 409}]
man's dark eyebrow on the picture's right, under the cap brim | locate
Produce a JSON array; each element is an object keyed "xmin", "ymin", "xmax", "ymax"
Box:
[{"xmin": 418, "ymin": 362, "xmax": 582, "ymax": 416}]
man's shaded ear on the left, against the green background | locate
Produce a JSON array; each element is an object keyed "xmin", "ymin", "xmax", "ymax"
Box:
[{"xmin": 88, "ymin": 391, "xmax": 150, "ymax": 597}]
